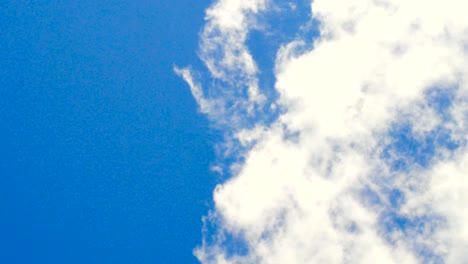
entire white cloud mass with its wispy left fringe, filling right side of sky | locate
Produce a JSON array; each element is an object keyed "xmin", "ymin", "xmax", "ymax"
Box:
[{"xmin": 175, "ymin": 0, "xmax": 468, "ymax": 263}]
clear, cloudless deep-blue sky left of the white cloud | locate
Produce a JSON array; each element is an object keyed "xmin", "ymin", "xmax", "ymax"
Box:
[{"xmin": 0, "ymin": 0, "xmax": 216, "ymax": 264}]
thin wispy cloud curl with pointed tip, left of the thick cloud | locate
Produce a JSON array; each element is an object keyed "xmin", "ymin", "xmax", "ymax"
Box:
[{"xmin": 174, "ymin": 0, "xmax": 269, "ymax": 129}]
